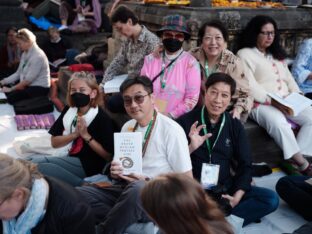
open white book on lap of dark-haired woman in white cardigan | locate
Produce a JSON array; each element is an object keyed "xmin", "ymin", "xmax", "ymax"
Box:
[{"xmin": 269, "ymin": 93, "xmax": 312, "ymax": 116}]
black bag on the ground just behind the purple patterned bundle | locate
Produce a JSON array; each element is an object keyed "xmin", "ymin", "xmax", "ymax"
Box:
[{"xmin": 13, "ymin": 96, "xmax": 54, "ymax": 115}]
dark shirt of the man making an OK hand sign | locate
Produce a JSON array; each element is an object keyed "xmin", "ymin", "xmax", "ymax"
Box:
[{"xmin": 177, "ymin": 108, "xmax": 252, "ymax": 195}]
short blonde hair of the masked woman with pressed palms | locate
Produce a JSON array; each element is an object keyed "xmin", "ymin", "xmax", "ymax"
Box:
[{"xmin": 66, "ymin": 71, "xmax": 103, "ymax": 107}]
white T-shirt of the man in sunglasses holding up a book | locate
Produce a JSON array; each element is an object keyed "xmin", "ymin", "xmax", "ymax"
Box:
[{"xmin": 121, "ymin": 113, "xmax": 192, "ymax": 177}]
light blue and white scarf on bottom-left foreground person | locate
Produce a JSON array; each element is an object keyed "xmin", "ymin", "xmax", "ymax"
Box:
[{"xmin": 2, "ymin": 178, "xmax": 49, "ymax": 234}]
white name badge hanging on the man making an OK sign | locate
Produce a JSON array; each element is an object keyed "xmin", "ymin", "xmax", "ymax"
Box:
[{"xmin": 200, "ymin": 163, "xmax": 220, "ymax": 189}]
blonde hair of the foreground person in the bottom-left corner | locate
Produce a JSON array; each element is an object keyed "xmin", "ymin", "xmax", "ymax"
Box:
[{"xmin": 0, "ymin": 153, "xmax": 42, "ymax": 199}]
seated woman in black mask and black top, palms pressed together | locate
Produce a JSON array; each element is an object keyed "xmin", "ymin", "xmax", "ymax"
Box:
[{"xmin": 31, "ymin": 72, "xmax": 114, "ymax": 186}]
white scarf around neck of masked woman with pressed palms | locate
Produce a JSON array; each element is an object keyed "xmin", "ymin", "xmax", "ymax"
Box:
[{"xmin": 63, "ymin": 107, "xmax": 99, "ymax": 150}]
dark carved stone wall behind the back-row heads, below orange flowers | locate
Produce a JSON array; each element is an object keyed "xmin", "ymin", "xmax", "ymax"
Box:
[{"xmin": 123, "ymin": 2, "xmax": 312, "ymax": 57}]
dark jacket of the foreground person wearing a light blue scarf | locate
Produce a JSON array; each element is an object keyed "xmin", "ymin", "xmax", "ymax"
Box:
[{"xmin": 0, "ymin": 177, "xmax": 95, "ymax": 234}]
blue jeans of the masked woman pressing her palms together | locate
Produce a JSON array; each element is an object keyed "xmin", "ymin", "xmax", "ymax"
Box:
[{"xmin": 28, "ymin": 156, "xmax": 86, "ymax": 186}]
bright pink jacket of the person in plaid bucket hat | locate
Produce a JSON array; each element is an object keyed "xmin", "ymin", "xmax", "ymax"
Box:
[{"xmin": 141, "ymin": 51, "xmax": 201, "ymax": 118}]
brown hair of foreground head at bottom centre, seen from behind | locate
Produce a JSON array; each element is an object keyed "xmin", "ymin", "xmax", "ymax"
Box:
[{"xmin": 141, "ymin": 173, "xmax": 234, "ymax": 234}]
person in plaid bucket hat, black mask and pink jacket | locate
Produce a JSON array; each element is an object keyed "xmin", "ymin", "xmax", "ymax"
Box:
[{"xmin": 141, "ymin": 15, "xmax": 200, "ymax": 119}]
